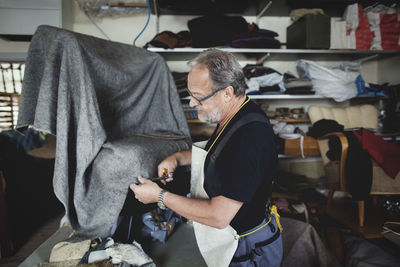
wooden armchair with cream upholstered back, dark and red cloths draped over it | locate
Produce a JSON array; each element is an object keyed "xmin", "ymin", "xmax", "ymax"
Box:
[{"xmin": 308, "ymin": 105, "xmax": 400, "ymax": 227}]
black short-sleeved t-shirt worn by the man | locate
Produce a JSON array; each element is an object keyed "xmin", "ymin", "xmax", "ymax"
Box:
[{"xmin": 204, "ymin": 99, "xmax": 277, "ymax": 233}]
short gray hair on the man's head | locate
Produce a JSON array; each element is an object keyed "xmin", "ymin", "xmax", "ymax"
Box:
[{"xmin": 188, "ymin": 48, "xmax": 247, "ymax": 96}]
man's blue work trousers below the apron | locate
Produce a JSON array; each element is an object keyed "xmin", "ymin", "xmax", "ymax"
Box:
[{"xmin": 229, "ymin": 215, "xmax": 283, "ymax": 267}]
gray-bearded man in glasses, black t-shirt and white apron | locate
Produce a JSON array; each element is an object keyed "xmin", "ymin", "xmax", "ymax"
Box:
[{"xmin": 130, "ymin": 49, "xmax": 282, "ymax": 266}]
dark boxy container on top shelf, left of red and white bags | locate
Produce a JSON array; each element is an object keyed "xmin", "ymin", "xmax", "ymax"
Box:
[{"xmin": 286, "ymin": 14, "xmax": 331, "ymax": 49}]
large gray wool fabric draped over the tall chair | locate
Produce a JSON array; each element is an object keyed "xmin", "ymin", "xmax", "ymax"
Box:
[{"xmin": 16, "ymin": 26, "xmax": 190, "ymax": 240}]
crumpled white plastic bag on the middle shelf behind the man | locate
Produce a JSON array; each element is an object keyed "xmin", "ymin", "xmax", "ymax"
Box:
[{"xmin": 296, "ymin": 60, "xmax": 360, "ymax": 102}]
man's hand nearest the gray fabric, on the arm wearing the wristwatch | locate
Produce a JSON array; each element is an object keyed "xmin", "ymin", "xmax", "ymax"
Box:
[{"xmin": 129, "ymin": 176, "xmax": 161, "ymax": 204}]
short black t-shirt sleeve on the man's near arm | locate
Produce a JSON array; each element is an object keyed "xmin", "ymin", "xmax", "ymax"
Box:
[{"xmin": 216, "ymin": 122, "xmax": 276, "ymax": 203}]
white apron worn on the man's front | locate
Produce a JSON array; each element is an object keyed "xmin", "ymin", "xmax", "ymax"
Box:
[{"xmin": 190, "ymin": 141, "xmax": 239, "ymax": 267}]
